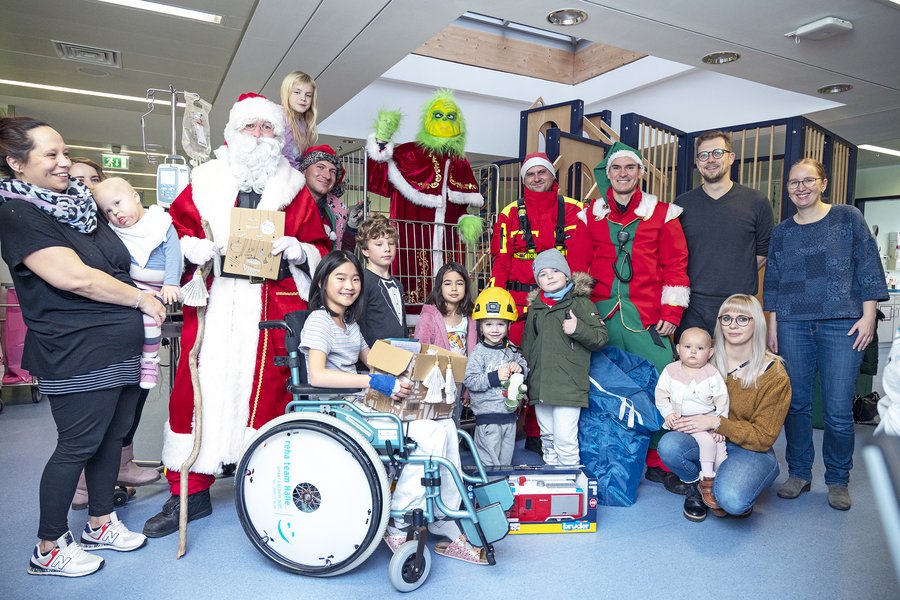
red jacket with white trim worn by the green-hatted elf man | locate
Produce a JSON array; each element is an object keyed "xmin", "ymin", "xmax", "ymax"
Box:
[{"xmin": 581, "ymin": 188, "xmax": 690, "ymax": 327}]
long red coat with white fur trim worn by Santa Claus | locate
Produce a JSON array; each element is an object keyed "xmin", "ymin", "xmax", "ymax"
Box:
[{"xmin": 162, "ymin": 154, "xmax": 331, "ymax": 478}]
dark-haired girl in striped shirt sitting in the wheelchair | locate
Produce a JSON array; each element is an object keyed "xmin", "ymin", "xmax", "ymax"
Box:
[{"xmin": 300, "ymin": 250, "xmax": 487, "ymax": 564}]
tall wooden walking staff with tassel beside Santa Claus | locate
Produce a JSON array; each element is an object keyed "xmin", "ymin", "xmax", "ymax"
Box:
[{"xmin": 178, "ymin": 219, "xmax": 219, "ymax": 558}]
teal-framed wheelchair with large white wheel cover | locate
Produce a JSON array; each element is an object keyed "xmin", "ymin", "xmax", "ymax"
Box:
[{"xmin": 235, "ymin": 311, "xmax": 513, "ymax": 592}]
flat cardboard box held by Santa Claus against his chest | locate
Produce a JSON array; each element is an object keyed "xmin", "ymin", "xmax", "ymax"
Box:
[{"xmin": 222, "ymin": 208, "xmax": 284, "ymax": 279}]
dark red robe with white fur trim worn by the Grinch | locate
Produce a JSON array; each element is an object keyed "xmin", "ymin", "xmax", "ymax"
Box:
[{"xmin": 366, "ymin": 134, "xmax": 484, "ymax": 304}]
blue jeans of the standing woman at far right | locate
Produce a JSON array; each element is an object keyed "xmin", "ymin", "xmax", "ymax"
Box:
[{"xmin": 778, "ymin": 319, "xmax": 862, "ymax": 485}]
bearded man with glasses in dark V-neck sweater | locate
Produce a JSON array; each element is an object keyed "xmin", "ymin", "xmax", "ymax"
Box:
[{"xmin": 675, "ymin": 131, "xmax": 773, "ymax": 336}]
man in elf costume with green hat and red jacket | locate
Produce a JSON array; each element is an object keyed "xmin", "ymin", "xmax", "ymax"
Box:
[{"xmin": 581, "ymin": 142, "xmax": 690, "ymax": 494}]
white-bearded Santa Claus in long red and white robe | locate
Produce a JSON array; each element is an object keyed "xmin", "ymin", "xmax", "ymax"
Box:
[{"xmin": 145, "ymin": 94, "xmax": 330, "ymax": 537}]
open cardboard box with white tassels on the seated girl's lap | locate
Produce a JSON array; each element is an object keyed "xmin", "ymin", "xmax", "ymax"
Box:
[{"xmin": 363, "ymin": 340, "xmax": 466, "ymax": 421}]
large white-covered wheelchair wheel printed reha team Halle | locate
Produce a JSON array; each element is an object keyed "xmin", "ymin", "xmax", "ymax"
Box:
[{"xmin": 235, "ymin": 413, "xmax": 391, "ymax": 577}]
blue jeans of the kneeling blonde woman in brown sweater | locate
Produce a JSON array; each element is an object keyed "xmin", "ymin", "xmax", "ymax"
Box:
[{"xmin": 657, "ymin": 431, "xmax": 781, "ymax": 515}]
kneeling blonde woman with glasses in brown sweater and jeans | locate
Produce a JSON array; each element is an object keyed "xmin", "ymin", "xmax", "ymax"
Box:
[{"xmin": 659, "ymin": 294, "xmax": 791, "ymax": 522}]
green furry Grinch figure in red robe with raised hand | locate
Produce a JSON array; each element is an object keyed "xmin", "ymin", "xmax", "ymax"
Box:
[{"xmin": 366, "ymin": 90, "xmax": 484, "ymax": 304}]
